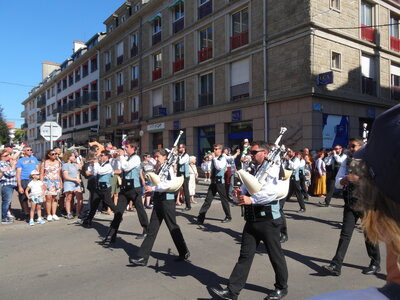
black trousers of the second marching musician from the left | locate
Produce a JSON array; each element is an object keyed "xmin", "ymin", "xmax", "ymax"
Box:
[{"xmin": 109, "ymin": 187, "xmax": 149, "ymax": 237}]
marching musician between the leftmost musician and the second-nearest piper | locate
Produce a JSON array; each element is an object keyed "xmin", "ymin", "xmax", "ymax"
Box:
[{"xmin": 102, "ymin": 140, "xmax": 149, "ymax": 243}]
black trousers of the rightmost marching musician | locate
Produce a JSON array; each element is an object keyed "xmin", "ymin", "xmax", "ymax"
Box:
[{"xmin": 332, "ymin": 204, "xmax": 381, "ymax": 269}]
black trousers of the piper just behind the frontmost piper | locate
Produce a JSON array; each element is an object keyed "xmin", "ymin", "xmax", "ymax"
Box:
[{"xmin": 138, "ymin": 193, "xmax": 189, "ymax": 260}]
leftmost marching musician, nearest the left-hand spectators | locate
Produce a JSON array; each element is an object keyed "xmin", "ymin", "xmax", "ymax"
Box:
[{"xmin": 82, "ymin": 150, "xmax": 115, "ymax": 227}]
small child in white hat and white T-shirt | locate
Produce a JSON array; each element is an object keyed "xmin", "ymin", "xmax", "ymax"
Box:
[{"xmin": 25, "ymin": 170, "xmax": 46, "ymax": 226}]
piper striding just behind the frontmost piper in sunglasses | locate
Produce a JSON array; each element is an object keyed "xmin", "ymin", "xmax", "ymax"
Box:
[{"xmin": 129, "ymin": 149, "xmax": 190, "ymax": 266}]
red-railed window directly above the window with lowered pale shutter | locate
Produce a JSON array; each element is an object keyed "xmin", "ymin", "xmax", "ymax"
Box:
[{"xmin": 231, "ymin": 7, "xmax": 249, "ymax": 49}]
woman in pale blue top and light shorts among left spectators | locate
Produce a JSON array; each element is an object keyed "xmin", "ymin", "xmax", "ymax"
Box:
[{"xmin": 62, "ymin": 151, "xmax": 83, "ymax": 219}]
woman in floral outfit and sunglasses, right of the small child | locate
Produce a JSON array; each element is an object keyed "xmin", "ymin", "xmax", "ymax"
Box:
[{"xmin": 40, "ymin": 150, "xmax": 62, "ymax": 222}]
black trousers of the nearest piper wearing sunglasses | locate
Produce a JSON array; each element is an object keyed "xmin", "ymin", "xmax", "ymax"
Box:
[{"xmin": 228, "ymin": 218, "xmax": 288, "ymax": 295}]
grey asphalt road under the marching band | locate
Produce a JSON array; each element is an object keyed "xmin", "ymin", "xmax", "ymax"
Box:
[{"xmin": 0, "ymin": 180, "xmax": 386, "ymax": 300}]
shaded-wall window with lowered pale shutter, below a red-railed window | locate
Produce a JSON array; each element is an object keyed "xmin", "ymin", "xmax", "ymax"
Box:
[{"xmin": 231, "ymin": 58, "xmax": 250, "ymax": 101}]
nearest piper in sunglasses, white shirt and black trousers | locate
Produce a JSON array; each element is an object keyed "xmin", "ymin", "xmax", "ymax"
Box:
[{"xmin": 211, "ymin": 141, "xmax": 288, "ymax": 300}]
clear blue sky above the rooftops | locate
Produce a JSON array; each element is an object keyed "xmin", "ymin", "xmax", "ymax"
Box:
[{"xmin": 0, "ymin": 0, "xmax": 125, "ymax": 128}]
